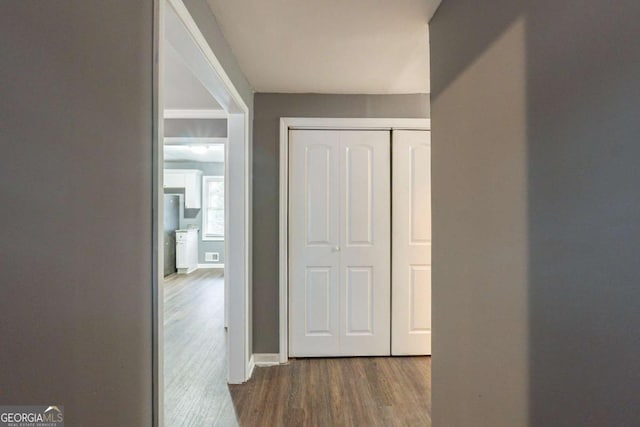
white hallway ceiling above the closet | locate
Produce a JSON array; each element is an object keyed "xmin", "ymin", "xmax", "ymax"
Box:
[{"xmin": 207, "ymin": 0, "xmax": 440, "ymax": 93}]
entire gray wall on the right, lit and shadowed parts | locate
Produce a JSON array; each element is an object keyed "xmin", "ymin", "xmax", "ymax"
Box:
[{"xmin": 430, "ymin": 0, "xmax": 640, "ymax": 427}]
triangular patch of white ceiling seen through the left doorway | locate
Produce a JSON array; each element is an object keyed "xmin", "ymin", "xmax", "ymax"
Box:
[{"xmin": 164, "ymin": 41, "xmax": 221, "ymax": 110}]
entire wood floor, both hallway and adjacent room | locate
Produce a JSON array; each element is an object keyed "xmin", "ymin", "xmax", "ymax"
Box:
[{"xmin": 165, "ymin": 270, "xmax": 431, "ymax": 427}]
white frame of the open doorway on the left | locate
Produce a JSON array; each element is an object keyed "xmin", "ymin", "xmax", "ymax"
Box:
[{"xmin": 151, "ymin": 0, "xmax": 253, "ymax": 426}]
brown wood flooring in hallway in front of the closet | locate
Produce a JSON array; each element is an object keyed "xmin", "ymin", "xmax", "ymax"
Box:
[{"xmin": 230, "ymin": 357, "xmax": 431, "ymax": 427}]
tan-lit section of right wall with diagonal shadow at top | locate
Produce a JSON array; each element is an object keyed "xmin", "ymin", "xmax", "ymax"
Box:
[{"xmin": 430, "ymin": 0, "xmax": 529, "ymax": 427}]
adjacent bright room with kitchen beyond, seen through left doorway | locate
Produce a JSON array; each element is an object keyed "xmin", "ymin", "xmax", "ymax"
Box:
[{"xmin": 162, "ymin": 5, "xmax": 232, "ymax": 426}]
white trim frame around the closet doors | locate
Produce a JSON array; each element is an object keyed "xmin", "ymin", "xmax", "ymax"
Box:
[{"xmin": 278, "ymin": 117, "xmax": 431, "ymax": 363}]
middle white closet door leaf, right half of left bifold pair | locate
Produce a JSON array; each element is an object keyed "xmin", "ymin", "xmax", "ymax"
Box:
[{"xmin": 340, "ymin": 131, "xmax": 391, "ymax": 356}]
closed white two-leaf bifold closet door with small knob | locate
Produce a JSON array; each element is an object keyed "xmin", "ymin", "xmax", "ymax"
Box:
[{"xmin": 289, "ymin": 130, "xmax": 391, "ymax": 357}]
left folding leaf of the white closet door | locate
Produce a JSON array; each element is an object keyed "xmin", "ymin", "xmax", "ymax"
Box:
[{"xmin": 288, "ymin": 130, "xmax": 340, "ymax": 357}]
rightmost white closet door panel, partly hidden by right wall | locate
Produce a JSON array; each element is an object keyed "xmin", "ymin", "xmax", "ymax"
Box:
[{"xmin": 391, "ymin": 130, "xmax": 431, "ymax": 355}]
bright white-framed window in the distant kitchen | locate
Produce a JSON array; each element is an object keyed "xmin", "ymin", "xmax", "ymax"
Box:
[{"xmin": 202, "ymin": 176, "xmax": 224, "ymax": 240}]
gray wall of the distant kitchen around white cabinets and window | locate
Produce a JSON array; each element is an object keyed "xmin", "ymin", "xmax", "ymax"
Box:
[{"xmin": 164, "ymin": 162, "xmax": 224, "ymax": 264}]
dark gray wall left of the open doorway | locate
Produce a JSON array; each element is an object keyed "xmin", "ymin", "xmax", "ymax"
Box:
[{"xmin": 0, "ymin": 0, "xmax": 153, "ymax": 426}]
